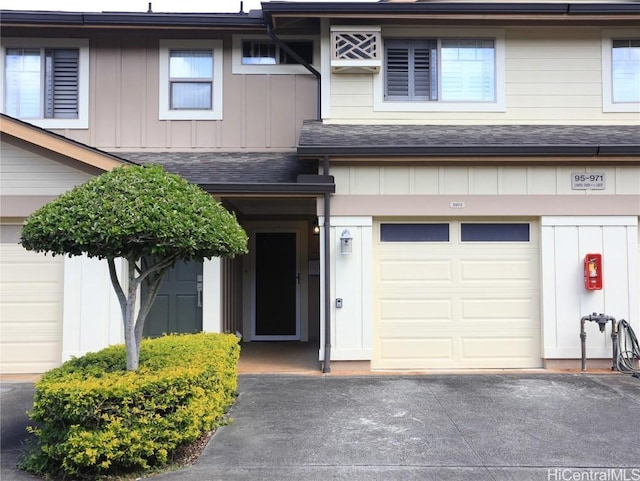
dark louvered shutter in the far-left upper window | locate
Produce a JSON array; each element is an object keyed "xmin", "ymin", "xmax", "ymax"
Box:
[{"xmin": 44, "ymin": 49, "xmax": 79, "ymax": 119}]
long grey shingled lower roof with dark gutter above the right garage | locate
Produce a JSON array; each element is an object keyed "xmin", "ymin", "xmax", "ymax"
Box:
[{"xmin": 298, "ymin": 121, "xmax": 640, "ymax": 164}]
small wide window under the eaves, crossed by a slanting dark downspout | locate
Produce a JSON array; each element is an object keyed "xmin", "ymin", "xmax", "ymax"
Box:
[{"xmin": 232, "ymin": 35, "xmax": 320, "ymax": 75}]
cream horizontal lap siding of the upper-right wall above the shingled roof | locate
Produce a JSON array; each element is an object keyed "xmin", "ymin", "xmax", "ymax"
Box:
[{"xmin": 326, "ymin": 26, "xmax": 640, "ymax": 125}]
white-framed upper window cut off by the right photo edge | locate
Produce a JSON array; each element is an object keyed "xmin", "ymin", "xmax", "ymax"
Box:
[{"xmin": 602, "ymin": 30, "xmax": 640, "ymax": 112}]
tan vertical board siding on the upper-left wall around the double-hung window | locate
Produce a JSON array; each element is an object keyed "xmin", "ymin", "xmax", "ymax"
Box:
[{"xmin": 46, "ymin": 32, "xmax": 316, "ymax": 150}]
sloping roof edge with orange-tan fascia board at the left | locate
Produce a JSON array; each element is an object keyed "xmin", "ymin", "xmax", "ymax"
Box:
[{"xmin": 0, "ymin": 114, "xmax": 133, "ymax": 171}]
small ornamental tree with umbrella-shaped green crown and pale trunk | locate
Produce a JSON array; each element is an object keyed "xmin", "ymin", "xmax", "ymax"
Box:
[{"xmin": 20, "ymin": 166, "xmax": 247, "ymax": 371}]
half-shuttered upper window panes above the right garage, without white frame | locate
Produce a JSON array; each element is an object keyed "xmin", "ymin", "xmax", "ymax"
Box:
[{"xmin": 384, "ymin": 39, "xmax": 496, "ymax": 102}]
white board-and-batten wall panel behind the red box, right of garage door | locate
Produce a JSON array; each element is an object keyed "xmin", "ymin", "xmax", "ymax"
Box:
[{"xmin": 541, "ymin": 216, "xmax": 640, "ymax": 359}]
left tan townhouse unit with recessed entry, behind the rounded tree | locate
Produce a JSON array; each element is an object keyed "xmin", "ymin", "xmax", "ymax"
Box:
[{"xmin": 0, "ymin": 11, "xmax": 334, "ymax": 372}]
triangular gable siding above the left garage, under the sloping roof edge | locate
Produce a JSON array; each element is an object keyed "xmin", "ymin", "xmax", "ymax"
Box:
[{"xmin": 0, "ymin": 142, "xmax": 91, "ymax": 196}]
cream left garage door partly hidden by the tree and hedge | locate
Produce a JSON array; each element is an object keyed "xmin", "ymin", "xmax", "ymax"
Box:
[{"xmin": 0, "ymin": 225, "xmax": 64, "ymax": 374}]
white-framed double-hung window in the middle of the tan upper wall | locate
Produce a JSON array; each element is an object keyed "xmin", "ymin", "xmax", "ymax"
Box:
[{"xmin": 159, "ymin": 40, "xmax": 223, "ymax": 120}]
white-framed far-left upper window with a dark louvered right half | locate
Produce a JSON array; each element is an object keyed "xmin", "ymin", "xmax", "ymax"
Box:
[{"xmin": 1, "ymin": 38, "xmax": 89, "ymax": 128}]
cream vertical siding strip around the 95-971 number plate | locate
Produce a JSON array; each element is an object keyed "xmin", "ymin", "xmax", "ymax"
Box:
[{"xmin": 331, "ymin": 166, "xmax": 640, "ymax": 196}]
